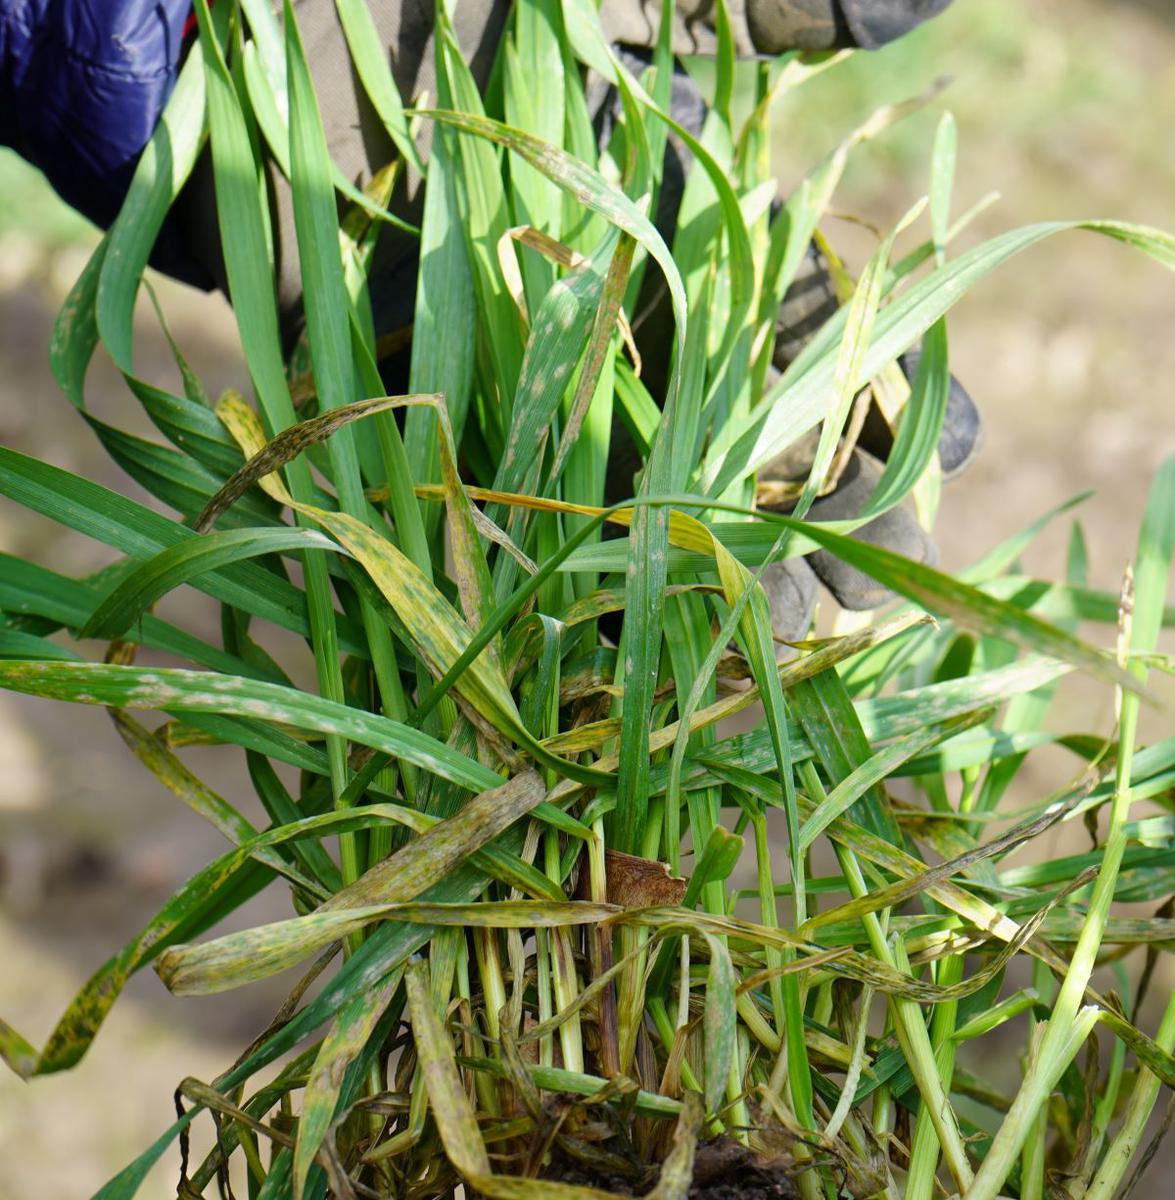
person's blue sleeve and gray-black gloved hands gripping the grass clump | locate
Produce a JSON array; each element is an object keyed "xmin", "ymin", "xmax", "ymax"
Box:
[{"xmin": 0, "ymin": 0, "xmax": 964, "ymax": 652}]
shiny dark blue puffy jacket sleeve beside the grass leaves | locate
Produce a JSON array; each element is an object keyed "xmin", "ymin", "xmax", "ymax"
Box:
[{"xmin": 0, "ymin": 0, "xmax": 211, "ymax": 282}]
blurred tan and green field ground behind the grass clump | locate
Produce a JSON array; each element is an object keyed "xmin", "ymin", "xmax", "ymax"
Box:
[{"xmin": 0, "ymin": 0, "xmax": 1175, "ymax": 1200}]
